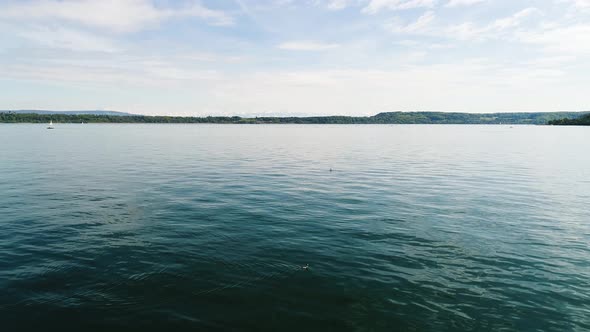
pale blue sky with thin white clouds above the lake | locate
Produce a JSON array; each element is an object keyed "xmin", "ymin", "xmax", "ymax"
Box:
[{"xmin": 0, "ymin": 0, "xmax": 590, "ymax": 116}]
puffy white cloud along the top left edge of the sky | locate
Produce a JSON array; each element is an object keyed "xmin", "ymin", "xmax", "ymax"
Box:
[{"xmin": 0, "ymin": 0, "xmax": 233, "ymax": 32}]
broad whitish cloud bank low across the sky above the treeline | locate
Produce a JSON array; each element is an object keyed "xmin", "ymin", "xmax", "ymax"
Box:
[{"xmin": 0, "ymin": 54, "xmax": 587, "ymax": 115}]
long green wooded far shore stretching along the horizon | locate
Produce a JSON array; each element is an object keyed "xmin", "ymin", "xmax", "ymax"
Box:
[{"xmin": 0, "ymin": 112, "xmax": 588, "ymax": 125}]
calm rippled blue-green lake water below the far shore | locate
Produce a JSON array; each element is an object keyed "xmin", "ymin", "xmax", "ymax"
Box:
[{"xmin": 0, "ymin": 124, "xmax": 590, "ymax": 331}]
